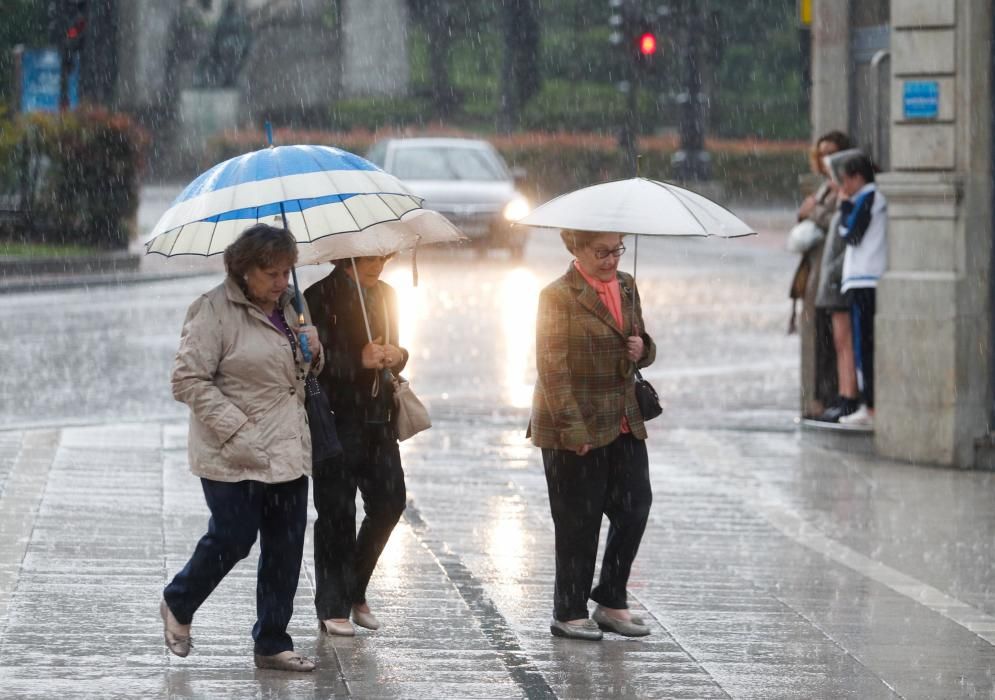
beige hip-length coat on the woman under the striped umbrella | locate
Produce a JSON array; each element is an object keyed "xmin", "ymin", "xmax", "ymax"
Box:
[{"xmin": 172, "ymin": 278, "xmax": 324, "ymax": 483}]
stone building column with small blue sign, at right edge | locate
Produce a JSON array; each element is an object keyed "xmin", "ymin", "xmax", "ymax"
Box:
[{"xmin": 875, "ymin": 0, "xmax": 992, "ymax": 467}]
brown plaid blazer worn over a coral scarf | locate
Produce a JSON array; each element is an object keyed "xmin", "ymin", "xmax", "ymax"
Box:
[{"xmin": 528, "ymin": 263, "xmax": 656, "ymax": 450}]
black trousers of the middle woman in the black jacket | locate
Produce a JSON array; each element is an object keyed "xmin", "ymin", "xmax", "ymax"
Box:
[{"xmin": 314, "ymin": 424, "xmax": 407, "ymax": 620}]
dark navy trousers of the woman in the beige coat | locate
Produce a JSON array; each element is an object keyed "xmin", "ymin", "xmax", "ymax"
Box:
[{"xmin": 163, "ymin": 476, "xmax": 308, "ymax": 656}]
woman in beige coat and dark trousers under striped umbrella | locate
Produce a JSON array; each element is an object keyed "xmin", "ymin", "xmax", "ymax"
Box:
[{"xmin": 160, "ymin": 224, "xmax": 324, "ymax": 671}]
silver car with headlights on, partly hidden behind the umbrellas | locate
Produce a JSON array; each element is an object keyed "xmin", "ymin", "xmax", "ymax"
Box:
[{"xmin": 366, "ymin": 137, "xmax": 530, "ymax": 260}]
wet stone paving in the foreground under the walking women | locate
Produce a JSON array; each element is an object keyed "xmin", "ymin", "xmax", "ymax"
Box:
[{"xmin": 0, "ymin": 412, "xmax": 995, "ymax": 698}]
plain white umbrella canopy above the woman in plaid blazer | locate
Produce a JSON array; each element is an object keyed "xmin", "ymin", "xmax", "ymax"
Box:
[{"xmin": 515, "ymin": 177, "xmax": 756, "ymax": 238}]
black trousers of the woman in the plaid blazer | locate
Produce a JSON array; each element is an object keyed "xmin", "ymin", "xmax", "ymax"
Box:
[{"xmin": 542, "ymin": 433, "xmax": 653, "ymax": 621}]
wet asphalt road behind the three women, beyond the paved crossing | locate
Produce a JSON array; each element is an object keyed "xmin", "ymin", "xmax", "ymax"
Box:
[{"xmin": 0, "ymin": 219, "xmax": 797, "ymax": 428}]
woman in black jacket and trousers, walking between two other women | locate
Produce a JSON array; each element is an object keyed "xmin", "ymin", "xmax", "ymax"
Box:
[{"xmin": 305, "ymin": 256, "xmax": 408, "ymax": 636}]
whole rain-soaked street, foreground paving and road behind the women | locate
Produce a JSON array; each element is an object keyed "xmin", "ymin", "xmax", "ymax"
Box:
[{"xmin": 0, "ymin": 216, "xmax": 995, "ymax": 698}]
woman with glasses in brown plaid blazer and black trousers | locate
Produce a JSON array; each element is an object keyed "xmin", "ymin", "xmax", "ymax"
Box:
[{"xmin": 529, "ymin": 230, "xmax": 656, "ymax": 640}]
